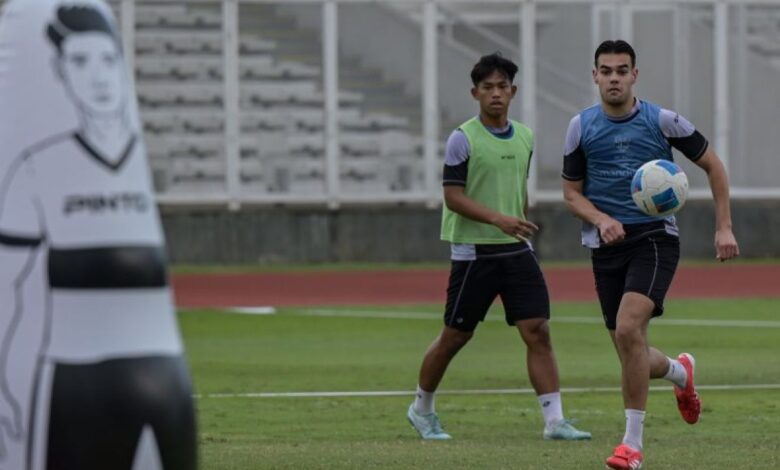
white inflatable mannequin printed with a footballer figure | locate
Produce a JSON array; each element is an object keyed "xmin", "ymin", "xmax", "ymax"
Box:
[{"xmin": 0, "ymin": 0, "xmax": 196, "ymax": 470}]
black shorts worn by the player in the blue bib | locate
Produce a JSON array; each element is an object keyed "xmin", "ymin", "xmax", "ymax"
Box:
[{"xmin": 591, "ymin": 233, "xmax": 680, "ymax": 330}]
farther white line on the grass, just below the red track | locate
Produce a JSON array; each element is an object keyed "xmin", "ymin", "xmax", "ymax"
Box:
[{"xmin": 284, "ymin": 309, "xmax": 780, "ymax": 328}]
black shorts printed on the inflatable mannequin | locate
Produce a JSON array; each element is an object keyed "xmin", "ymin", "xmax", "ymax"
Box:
[{"xmin": 46, "ymin": 356, "xmax": 197, "ymax": 470}]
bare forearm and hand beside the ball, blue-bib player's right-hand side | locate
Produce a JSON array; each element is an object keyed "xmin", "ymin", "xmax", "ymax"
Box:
[{"xmin": 694, "ymin": 146, "xmax": 739, "ymax": 261}]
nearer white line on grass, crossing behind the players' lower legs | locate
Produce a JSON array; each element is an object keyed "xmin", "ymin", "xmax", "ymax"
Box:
[{"xmin": 195, "ymin": 384, "xmax": 780, "ymax": 398}]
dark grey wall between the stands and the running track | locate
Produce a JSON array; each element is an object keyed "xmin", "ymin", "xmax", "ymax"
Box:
[{"xmin": 162, "ymin": 200, "xmax": 780, "ymax": 264}]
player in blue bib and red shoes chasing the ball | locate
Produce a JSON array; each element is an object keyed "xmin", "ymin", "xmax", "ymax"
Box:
[{"xmin": 562, "ymin": 40, "xmax": 739, "ymax": 469}]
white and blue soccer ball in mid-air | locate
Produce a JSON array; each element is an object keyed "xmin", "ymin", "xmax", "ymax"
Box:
[{"xmin": 631, "ymin": 160, "xmax": 688, "ymax": 217}]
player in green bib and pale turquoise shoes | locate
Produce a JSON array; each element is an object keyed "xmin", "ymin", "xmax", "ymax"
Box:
[{"xmin": 407, "ymin": 53, "xmax": 590, "ymax": 440}]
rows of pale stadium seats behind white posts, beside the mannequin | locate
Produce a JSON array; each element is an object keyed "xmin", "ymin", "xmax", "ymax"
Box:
[{"xmin": 135, "ymin": 2, "xmax": 422, "ymax": 196}]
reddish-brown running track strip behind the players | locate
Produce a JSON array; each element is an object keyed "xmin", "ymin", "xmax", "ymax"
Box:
[{"xmin": 172, "ymin": 264, "xmax": 780, "ymax": 308}]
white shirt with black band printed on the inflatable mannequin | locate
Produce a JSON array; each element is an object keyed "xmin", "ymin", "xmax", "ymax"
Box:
[{"xmin": 0, "ymin": 133, "xmax": 182, "ymax": 363}]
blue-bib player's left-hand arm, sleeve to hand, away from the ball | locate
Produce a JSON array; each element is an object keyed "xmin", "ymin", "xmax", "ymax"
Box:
[{"xmin": 561, "ymin": 115, "xmax": 626, "ymax": 245}]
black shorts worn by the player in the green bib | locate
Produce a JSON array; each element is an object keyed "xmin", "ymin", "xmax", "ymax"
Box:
[{"xmin": 444, "ymin": 250, "xmax": 550, "ymax": 331}]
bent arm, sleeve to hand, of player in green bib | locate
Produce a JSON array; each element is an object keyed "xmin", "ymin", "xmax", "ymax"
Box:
[{"xmin": 443, "ymin": 130, "xmax": 539, "ymax": 239}]
